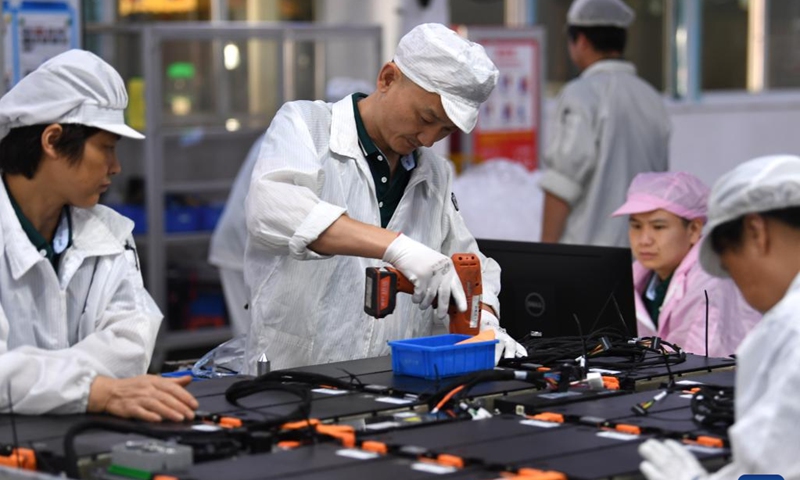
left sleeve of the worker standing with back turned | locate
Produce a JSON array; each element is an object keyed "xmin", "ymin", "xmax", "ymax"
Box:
[{"xmin": 539, "ymin": 91, "xmax": 597, "ymax": 205}]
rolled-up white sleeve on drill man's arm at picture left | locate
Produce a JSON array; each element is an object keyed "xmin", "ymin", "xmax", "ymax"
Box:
[{"xmin": 245, "ymin": 103, "xmax": 346, "ymax": 260}]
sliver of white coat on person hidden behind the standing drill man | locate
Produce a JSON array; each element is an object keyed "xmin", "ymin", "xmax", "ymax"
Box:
[{"xmin": 208, "ymin": 135, "xmax": 264, "ymax": 336}]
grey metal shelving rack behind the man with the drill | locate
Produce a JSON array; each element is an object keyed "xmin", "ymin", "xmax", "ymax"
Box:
[{"xmin": 86, "ymin": 22, "xmax": 382, "ymax": 369}]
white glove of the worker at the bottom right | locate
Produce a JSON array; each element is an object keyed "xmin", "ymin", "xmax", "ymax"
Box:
[{"xmin": 639, "ymin": 439, "xmax": 708, "ymax": 480}]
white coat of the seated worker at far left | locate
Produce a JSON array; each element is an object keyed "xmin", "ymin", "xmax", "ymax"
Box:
[{"xmin": 0, "ymin": 178, "xmax": 162, "ymax": 414}]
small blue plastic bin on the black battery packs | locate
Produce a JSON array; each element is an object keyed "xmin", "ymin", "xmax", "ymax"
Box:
[{"xmin": 389, "ymin": 334, "xmax": 497, "ymax": 380}]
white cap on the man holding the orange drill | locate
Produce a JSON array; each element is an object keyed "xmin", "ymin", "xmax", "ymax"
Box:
[{"xmin": 394, "ymin": 23, "xmax": 498, "ymax": 133}]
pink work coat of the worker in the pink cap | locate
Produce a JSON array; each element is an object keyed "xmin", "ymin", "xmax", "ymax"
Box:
[{"xmin": 633, "ymin": 243, "xmax": 761, "ymax": 357}]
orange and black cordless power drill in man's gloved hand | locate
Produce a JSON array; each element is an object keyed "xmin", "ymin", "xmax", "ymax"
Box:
[{"xmin": 364, "ymin": 253, "xmax": 483, "ymax": 335}]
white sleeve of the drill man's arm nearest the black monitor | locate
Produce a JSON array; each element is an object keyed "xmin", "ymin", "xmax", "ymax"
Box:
[{"xmin": 442, "ymin": 166, "xmax": 500, "ymax": 318}]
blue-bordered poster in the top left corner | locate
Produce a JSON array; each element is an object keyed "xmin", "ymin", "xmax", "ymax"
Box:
[{"xmin": 3, "ymin": 0, "xmax": 80, "ymax": 91}]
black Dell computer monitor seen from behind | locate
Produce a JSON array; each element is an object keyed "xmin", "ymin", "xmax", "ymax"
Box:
[{"xmin": 478, "ymin": 240, "xmax": 636, "ymax": 340}]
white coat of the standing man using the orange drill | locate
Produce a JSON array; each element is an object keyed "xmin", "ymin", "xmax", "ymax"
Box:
[{"xmin": 244, "ymin": 96, "xmax": 500, "ymax": 371}]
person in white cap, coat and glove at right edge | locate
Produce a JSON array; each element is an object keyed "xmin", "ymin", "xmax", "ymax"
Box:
[{"xmin": 639, "ymin": 155, "xmax": 800, "ymax": 480}]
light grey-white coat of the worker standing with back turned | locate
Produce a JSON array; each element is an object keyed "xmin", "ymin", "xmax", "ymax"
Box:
[{"xmin": 539, "ymin": 60, "xmax": 671, "ymax": 247}]
